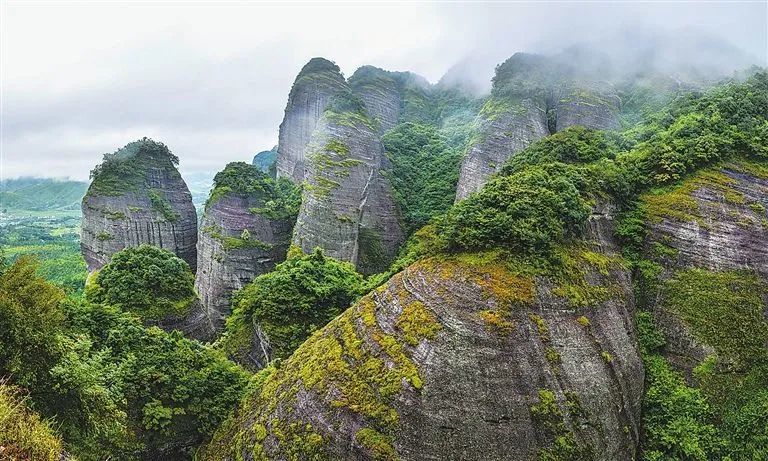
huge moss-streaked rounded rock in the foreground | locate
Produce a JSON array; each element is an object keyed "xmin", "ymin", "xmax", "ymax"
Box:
[{"xmin": 200, "ymin": 237, "xmax": 643, "ymax": 460}]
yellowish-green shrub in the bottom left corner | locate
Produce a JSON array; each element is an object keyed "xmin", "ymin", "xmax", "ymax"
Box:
[{"xmin": 0, "ymin": 383, "xmax": 64, "ymax": 461}]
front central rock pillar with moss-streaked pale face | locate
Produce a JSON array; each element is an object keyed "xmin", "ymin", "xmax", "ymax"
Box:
[{"xmin": 293, "ymin": 113, "xmax": 403, "ymax": 273}]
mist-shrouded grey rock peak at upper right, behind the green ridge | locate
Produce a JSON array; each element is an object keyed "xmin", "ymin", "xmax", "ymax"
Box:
[{"xmin": 456, "ymin": 53, "xmax": 620, "ymax": 201}]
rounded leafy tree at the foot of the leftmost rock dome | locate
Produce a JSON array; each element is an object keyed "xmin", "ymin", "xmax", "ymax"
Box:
[{"xmin": 85, "ymin": 245, "xmax": 196, "ymax": 320}]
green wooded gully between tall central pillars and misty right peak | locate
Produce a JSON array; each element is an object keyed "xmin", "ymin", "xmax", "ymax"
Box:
[{"xmin": 382, "ymin": 122, "xmax": 462, "ymax": 234}]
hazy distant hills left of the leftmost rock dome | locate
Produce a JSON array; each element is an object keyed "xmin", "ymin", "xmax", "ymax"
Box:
[{"xmin": 0, "ymin": 178, "xmax": 88, "ymax": 211}]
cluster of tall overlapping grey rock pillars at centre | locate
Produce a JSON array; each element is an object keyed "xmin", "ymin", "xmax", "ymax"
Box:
[{"xmin": 277, "ymin": 58, "xmax": 410, "ymax": 273}]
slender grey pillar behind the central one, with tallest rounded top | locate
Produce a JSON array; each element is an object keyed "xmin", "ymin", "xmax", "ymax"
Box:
[{"xmin": 277, "ymin": 58, "xmax": 346, "ymax": 183}]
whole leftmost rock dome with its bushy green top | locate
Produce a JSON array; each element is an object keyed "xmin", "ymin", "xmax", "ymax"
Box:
[{"xmin": 80, "ymin": 138, "xmax": 197, "ymax": 272}]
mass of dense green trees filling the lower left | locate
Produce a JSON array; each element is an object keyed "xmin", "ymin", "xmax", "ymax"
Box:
[{"xmin": 0, "ymin": 253, "xmax": 248, "ymax": 460}]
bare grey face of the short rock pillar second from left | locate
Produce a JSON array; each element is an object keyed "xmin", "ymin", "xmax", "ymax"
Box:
[{"xmin": 195, "ymin": 194, "xmax": 295, "ymax": 331}]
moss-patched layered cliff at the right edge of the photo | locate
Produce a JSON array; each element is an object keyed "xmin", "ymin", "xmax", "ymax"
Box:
[{"xmin": 642, "ymin": 161, "xmax": 768, "ymax": 378}]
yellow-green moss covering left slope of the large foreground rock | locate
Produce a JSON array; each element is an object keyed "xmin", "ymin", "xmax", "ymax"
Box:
[{"xmin": 198, "ymin": 290, "xmax": 436, "ymax": 460}]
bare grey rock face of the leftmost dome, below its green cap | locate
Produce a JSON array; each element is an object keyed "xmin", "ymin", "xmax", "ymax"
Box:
[{"xmin": 80, "ymin": 147, "xmax": 197, "ymax": 272}]
